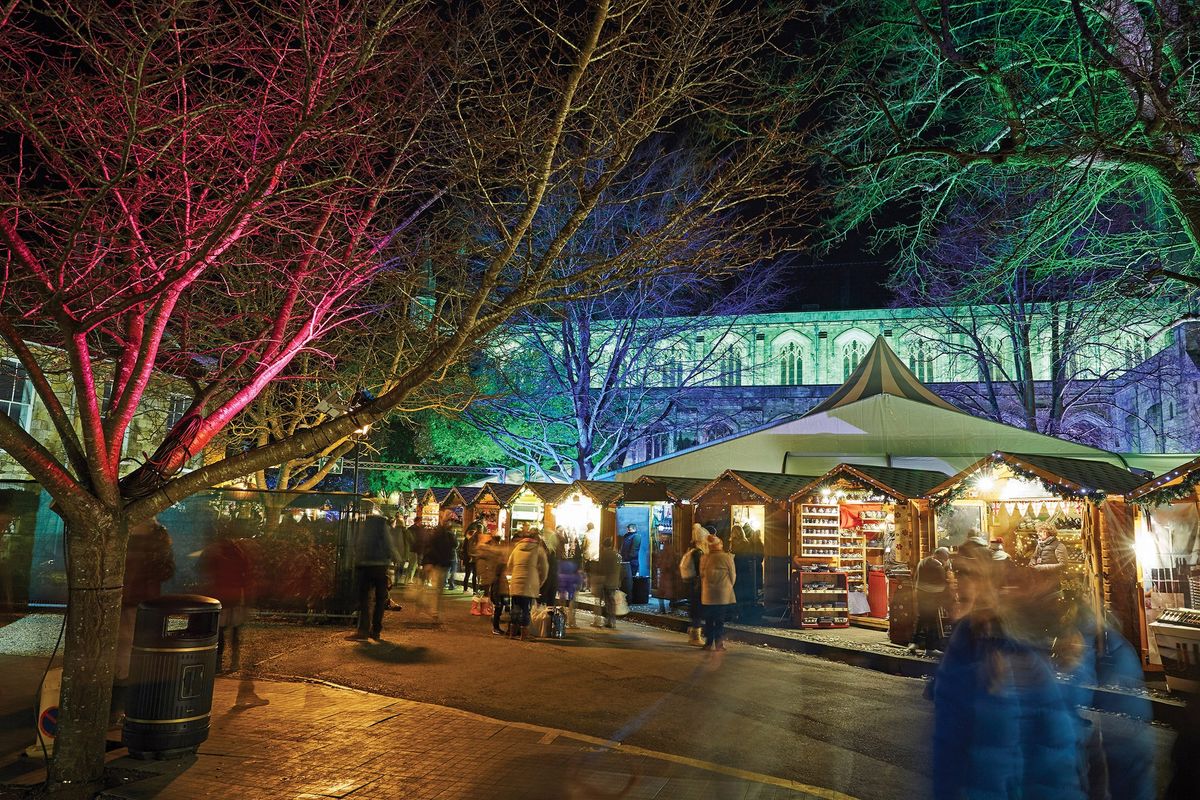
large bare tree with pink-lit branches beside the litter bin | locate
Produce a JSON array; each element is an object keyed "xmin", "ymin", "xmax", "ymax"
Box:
[{"xmin": 0, "ymin": 0, "xmax": 799, "ymax": 796}]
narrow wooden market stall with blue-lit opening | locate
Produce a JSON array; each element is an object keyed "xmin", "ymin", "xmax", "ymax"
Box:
[{"xmin": 617, "ymin": 475, "xmax": 710, "ymax": 602}]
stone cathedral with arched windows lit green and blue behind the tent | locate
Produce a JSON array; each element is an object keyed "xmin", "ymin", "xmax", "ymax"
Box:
[{"xmin": 625, "ymin": 308, "xmax": 1200, "ymax": 464}]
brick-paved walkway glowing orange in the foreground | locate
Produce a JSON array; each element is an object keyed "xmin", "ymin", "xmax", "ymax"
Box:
[{"xmin": 93, "ymin": 679, "xmax": 848, "ymax": 800}]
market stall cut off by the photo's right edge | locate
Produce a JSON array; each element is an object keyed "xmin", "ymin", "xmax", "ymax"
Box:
[{"xmin": 1129, "ymin": 458, "xmax": 1200, "ymax": 682}]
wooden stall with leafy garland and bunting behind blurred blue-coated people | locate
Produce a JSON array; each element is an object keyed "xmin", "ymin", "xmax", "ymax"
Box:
[{"xmin": 929, "ymin": 452, "xmax": 1146, "ymax": 652}]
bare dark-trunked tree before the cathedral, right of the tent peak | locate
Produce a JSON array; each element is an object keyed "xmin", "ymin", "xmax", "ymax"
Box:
[{"xmin": 892, "ymin": 179, "xmax": 1177, "ymax": 444}]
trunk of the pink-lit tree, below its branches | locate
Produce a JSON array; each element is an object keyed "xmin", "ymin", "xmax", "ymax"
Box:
[{"xmin": 48, "ymin": 521, "xmax": 126, "ymax": 800}]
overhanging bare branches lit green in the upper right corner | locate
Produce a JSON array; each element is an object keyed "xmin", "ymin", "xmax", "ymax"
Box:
[{"xmin": 820, "ymin": 0, "xmax": 1200, "ymax": 285}]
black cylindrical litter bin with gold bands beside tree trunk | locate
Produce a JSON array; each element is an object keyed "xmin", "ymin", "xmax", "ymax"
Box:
[{"xmin": 121, "ymin": 595, "xmax": 221, "ymax": 758}]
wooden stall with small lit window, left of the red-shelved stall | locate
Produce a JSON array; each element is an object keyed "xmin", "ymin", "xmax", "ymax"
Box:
[{"xmin": 694, "ymin": 469, "xmax": 816, "ymax": 620}]
